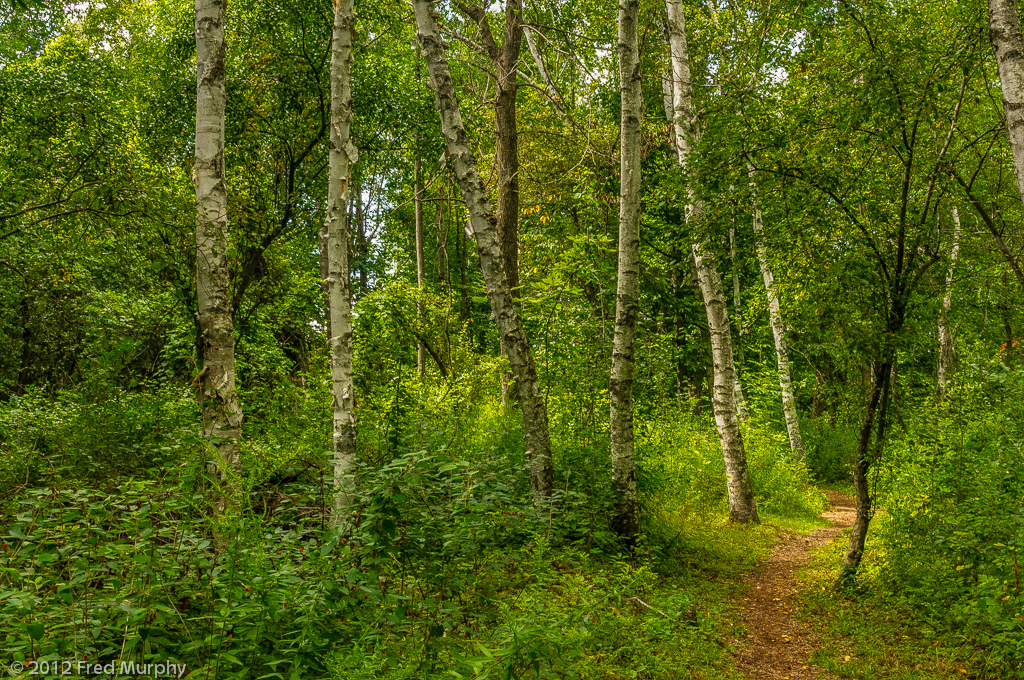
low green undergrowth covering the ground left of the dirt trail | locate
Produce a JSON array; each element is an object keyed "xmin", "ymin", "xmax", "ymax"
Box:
[{"xmin": 0, "ymin": 385, "xmax": 821, "ymax": 678}]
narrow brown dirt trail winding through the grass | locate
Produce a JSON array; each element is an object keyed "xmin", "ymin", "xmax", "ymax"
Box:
[{"xmin": 733, "ymin": 491, "xmax": 856, "ymax": 680}]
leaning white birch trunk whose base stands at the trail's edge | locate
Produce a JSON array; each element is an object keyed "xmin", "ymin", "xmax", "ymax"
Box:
[{"xmin": 667, "ymin": 0, "xmax": 759, "ymax": 522}]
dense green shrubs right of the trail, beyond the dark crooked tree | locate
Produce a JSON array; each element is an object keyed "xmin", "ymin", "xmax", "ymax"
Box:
[{"xmin": 877, "ymin": 365, "xmax": 1024, "ymax": 677}]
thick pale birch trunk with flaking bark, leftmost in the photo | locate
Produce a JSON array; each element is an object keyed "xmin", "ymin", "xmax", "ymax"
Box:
[{"xmin": 195, "ymin": 0, "xmax": 242, "ymax": 512}]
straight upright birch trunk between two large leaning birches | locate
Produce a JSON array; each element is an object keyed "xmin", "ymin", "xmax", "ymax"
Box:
[{"xmin": 608, "ymin": 0, "xmax": 643, "ymax": 545}]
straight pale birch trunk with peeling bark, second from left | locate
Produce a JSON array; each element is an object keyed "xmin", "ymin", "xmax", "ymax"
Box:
[{"xmin": 326, "ymin": 0, "xmax": 359, "ymax": 522}]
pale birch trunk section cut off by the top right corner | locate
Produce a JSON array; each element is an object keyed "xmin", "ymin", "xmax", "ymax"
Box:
[{"xmin": 988, "ymin": 0, "xmax": 1024, "ymax": 209}]
